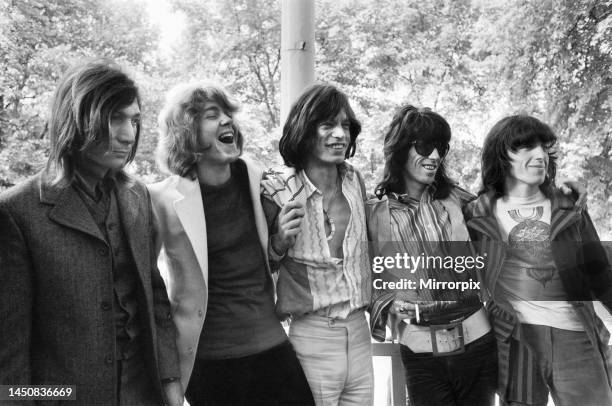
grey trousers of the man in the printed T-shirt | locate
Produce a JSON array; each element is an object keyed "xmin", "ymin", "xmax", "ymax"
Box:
[{"xmin": 507, "ymin": 324, "xmax": 612, "ymax": 406}]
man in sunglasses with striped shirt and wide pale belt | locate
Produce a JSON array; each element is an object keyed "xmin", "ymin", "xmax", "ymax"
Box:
[{"xmin": 366, "ymin": 105, "xmax": 497, "ymax": 406}]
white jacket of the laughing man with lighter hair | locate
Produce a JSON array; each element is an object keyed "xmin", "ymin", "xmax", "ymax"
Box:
[{"xmin": 147, "ymin": 158, "xmax": 270, "ymax": 389}]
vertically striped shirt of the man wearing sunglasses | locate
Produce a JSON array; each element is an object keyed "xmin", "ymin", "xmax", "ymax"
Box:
[{"xmin": 367, "ymin": 187, "xmax": 481, "ymax": 343}]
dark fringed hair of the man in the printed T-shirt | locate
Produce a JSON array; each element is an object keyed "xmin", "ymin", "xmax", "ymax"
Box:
[{"xmin": 478, "ymin": 114, "xmax": 557, "ymax": 197}]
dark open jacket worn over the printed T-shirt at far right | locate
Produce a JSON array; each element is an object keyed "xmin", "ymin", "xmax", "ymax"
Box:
[{"xmin": 464, "ymin": 190, "xmax": 612, "ymax": 404}]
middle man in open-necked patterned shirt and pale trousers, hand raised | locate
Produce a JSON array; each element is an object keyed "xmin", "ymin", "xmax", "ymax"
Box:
[{"xmin": 262, "ymin": 84, "xmax": 373, "ymax": 405}]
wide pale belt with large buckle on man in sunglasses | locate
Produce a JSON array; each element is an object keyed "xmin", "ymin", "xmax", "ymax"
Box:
[{"xmin": 400, "ymin": 308, "xmax": 491, "ymax": 356}]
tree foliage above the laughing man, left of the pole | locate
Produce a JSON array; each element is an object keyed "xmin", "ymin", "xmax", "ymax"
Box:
[{"xmin": 167, "ymin": 0, "xmax": 280, "ymax": 130}]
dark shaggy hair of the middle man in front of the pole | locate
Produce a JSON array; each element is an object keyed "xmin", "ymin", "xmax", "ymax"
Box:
[{"xmin": 278, "ymin": 84, "xmax": 361, "ymax": 170}]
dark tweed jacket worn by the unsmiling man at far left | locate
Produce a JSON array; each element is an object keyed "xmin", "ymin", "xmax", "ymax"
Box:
[{"xmin": 0, "ymin": 174, "xmax": 180, "ymax": 406}]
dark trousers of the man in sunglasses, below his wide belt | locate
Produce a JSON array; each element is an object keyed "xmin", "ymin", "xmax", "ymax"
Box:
[{"xmin": 400, "ymin": 332, "xmax": 497, "ymax": 406}]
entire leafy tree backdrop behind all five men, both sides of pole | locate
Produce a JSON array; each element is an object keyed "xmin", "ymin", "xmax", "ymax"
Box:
[{"xmin": 0, "ymin": 0, "xmax": 612, "ymax": 238}]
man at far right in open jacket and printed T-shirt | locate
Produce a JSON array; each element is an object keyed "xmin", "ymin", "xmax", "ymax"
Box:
[{"xmin": 466, "ymin": 115, "xmax": 612, "ymax": 406}]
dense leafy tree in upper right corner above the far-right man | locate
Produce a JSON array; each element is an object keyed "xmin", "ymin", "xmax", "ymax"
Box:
[{"xmin": 468, "ymin": 0, "xmax": 612, "ymax": 238}]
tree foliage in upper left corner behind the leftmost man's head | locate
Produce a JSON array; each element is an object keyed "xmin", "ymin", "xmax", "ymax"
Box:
[{"xmin": 0, "ymin": 0, "xmax": 156, "ymax": 187}]
